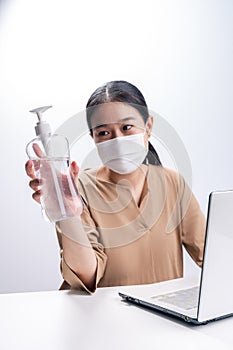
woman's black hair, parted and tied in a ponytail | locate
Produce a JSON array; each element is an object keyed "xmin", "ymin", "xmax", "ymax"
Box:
[{"xmin": 86, "ymin": 80, "xmax": 162, "ymax": 166}]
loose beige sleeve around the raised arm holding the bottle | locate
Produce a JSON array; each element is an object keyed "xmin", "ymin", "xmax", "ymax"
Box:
[{"xmin": 56, "ymin": 196, "xmax": 107, "ymax": 294}]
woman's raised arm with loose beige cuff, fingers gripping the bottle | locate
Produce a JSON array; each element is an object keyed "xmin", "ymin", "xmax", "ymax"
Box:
[{"xmin": 25, "ymin": 160, "xmax": 106, "ymax": 292}]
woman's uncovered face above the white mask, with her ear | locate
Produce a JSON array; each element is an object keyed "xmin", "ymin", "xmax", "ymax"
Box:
[{"xmin": 91, "ymin": 102, "xmax": 153, "ymax": 145}]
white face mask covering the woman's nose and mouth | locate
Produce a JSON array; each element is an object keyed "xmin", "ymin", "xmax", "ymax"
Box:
[{"xmin": 96, "ymin": 133, "xmax": 147, "ymax": 174}]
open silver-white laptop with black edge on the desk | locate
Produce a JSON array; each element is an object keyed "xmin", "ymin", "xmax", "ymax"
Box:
[{"xmin": 119, "ymin": 190, "xmax": 233, "ymax": 324}]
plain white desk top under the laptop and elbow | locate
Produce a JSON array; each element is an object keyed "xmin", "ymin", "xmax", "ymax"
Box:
[{"xmin": 0, "ymin": 287, "xmax": 233, "ymax": 350}]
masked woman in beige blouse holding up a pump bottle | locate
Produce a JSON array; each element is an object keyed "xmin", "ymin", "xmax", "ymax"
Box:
[{"xmin": 26, "ymin": 81, "xmax": 205, "ymax": 293}]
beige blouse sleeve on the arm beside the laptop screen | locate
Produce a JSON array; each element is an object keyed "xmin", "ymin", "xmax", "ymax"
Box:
[{"xmin": 181, "ymin": 177, "xmax": 206, "ymax": 267}]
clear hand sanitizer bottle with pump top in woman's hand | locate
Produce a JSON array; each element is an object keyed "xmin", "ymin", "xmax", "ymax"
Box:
[{"xmin": 26, "ymin": 106, "xmax": 83, "ymax": 222}]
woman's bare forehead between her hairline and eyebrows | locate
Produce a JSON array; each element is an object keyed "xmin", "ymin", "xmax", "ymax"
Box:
[{"xmin": 88, "ymin": 102, "xmax": 143, "ymax": 128}]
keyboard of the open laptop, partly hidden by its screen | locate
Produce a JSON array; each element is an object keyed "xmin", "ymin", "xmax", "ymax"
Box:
[{"xmin": 151, "ymin": 286, "xmax": 199, "ymax": 310}]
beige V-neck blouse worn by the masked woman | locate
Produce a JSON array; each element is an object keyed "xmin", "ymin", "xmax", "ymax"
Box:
[{"xmin": 57, "ymin": 165, "xmax": 206, "ymax": 292}]
